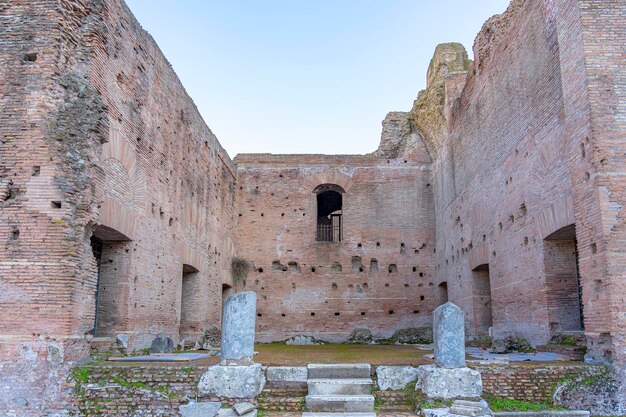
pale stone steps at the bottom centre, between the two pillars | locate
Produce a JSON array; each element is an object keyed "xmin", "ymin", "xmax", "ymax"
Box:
[{"xmin": 302, "ymin": 364, "xmax": 376, "ymax": 417}]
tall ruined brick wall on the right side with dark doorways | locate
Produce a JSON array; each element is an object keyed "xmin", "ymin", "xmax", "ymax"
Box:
[{"xmin": 412, "ymin": 0, "xmax": 625, "ymax": 384}]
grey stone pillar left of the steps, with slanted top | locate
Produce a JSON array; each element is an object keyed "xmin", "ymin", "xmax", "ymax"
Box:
[{"xmin": 222, "ymin": 291, "xmax": 256, "ymax": 365}]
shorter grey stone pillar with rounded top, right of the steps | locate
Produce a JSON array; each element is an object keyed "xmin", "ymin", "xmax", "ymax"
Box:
[{"xmin": 433, "ymin": 302, "xmax": 465, "ymax": 369}]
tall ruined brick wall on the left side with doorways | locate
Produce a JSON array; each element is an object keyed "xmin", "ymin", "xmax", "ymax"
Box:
[{"xmin": 0, "ymin": 0, "xmax": 235, "ymax": 416}]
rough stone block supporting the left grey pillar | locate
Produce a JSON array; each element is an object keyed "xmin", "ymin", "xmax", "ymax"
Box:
[{"xmin": 198, "ymin": 363, "xmax": 265, "ymax": 398}]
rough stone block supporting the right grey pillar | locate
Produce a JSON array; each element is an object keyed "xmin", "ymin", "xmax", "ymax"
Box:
[{"xmin": 415, "ymin": 365, "xmax": 483, "ymax": 400}]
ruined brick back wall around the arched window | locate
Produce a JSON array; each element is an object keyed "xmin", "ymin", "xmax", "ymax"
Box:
[{"xmin": 235, "ymin": 113, "xmax": 439, "ymax": 341}]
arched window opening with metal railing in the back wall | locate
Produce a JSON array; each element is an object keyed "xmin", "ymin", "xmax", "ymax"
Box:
[{"xmin": 314, "ymin": 184, "xmax": 344, "ymax": 242}]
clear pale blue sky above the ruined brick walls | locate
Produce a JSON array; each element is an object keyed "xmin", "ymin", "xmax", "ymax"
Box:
[{"xmin": 126, "ymin": 0, "xmax": 509, "ymax": 157}]
